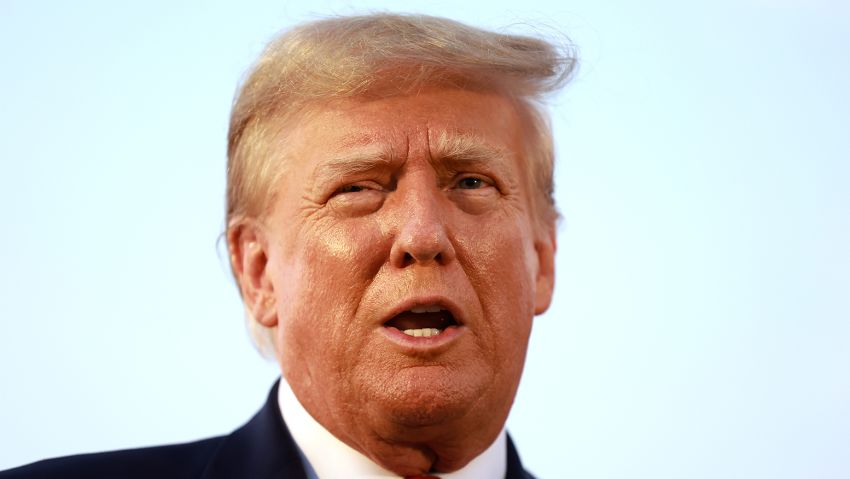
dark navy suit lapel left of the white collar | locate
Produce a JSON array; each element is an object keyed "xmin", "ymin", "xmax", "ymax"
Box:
[{"xmin": 202, "ymin": 383, "xmax": 307, "ymax": 479}]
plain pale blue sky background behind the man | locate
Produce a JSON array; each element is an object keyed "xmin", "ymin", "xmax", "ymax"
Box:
[{"xmin": 0, "ymin": 0, "xmax": 850, "ymax": 479}]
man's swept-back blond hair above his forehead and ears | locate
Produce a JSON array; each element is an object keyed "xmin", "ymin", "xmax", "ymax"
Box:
[{"xmin": 227, "ymin": 13, "xmax": 576, "ymax": 351}]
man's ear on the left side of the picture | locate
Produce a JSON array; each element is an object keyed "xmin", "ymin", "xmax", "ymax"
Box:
[{"xmin": 227, "ymin": 221, "xmax": 277, "ymax": 328}]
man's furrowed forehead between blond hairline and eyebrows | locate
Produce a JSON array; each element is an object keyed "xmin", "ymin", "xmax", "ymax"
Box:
[{"xmin": 278, "ymin": 89, "xmax": 523, "ymax": 169}]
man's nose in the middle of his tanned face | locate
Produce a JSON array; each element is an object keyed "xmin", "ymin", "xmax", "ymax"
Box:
[{"xmin": 390, "ymin": 191, "xmax": 455, "ymax": 268}]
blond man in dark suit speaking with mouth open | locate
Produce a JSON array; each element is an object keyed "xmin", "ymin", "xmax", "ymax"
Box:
[{"xmin": 0, "ymin": 14, "xmax": 574, "ymax": 479}]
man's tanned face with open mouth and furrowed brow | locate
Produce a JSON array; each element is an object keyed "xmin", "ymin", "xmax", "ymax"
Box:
[{"xmin": 243, "ymin": 89, "xmax": 554, "ymax": 469}]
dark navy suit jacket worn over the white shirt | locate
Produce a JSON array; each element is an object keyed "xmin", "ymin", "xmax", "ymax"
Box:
[{"xmin": 0, "ymin": 384, "xmax": 533, "ymax": 479}]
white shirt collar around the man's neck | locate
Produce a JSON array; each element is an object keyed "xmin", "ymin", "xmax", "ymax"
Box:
[{"xmin": 277, "ymin": 378, "xmax": 508, "ymax": 479}]
